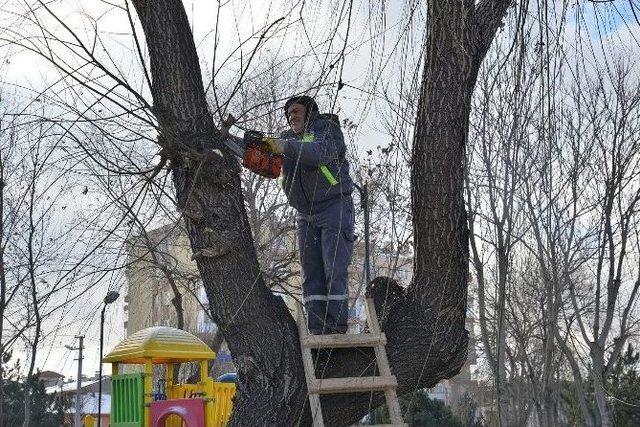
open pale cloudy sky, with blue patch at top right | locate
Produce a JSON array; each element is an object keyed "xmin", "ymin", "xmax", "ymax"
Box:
[{"xmin": 0, "ymin": 0, "xmax": 640, "ymax": 377}]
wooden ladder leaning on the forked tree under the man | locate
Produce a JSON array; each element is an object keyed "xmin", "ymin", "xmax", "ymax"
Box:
[{"xmin": 298, "ymin": 298, "xmax": 407, "ymax": 427}]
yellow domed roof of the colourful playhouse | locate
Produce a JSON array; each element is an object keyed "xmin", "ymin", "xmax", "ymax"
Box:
[{"xmin": 103, "ymin": 326, "xmax": 216, "ymax": 364}]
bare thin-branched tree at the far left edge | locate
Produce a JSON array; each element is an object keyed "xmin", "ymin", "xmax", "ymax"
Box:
[{"xmin": 0, "ymin": 99, "xmax": 109, "ymax": 426}]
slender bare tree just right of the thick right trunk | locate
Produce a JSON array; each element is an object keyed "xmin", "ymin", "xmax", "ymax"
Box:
[{"xmin": 466, "ymin": 35, "xmax": 536, "ymax": 425}]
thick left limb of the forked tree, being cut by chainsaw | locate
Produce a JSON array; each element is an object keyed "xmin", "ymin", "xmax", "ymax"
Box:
[{"xmin": 129, "ymin": 0, "xmax": 306, "ymax": 425}]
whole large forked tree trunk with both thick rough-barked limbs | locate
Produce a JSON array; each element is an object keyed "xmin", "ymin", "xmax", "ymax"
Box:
[{"xmin": 129, "ymin": 0, "xmax": 509, "ymax": 425}]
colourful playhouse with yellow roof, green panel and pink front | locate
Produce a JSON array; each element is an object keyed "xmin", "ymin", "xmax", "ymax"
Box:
[{"xmin": 103, "ymin": 326, "xmax": 236, "ymax": 427}]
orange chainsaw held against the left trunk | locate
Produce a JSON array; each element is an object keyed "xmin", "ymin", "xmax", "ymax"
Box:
[{"xmin": 222, "ymin": 114, "xmax": 282, "ymax": 178}]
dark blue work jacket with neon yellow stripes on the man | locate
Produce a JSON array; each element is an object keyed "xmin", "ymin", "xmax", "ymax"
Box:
[{"xmin": 281, "ymin": 114, "xmax": 353, "ymax": 214}]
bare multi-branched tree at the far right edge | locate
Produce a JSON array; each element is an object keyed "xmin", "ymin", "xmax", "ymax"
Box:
[{"xmin": 547, "ymin": 62, "xmax": 640, "ymax": 425}]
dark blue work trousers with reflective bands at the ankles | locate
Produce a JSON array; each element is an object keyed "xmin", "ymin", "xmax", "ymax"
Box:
[{"xmin": 297, "ymin": 196, "xmax": 355, "ymax": 334}]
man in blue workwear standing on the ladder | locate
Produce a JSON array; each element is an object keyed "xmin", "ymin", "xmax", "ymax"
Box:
[{"xmin": 274, "ymin": 96, "xmax": 355, "ymax": 334}]
